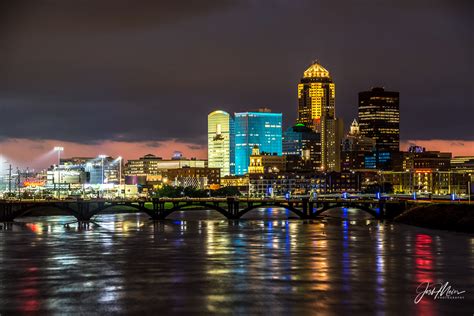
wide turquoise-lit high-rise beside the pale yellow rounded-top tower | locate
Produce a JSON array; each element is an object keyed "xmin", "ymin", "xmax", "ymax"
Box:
[{"xmin": 235, "ymin": 109, "xmax": 282, "ymax": 175}]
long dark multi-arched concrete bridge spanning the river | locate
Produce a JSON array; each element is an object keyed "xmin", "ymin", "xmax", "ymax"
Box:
[{"xmin": 0, "ymin": 197, "xmax": 415, "ymax": 222}]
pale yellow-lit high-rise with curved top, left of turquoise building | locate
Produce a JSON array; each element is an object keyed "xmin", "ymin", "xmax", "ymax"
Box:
[{"xmin": 207, "ymin": 111, "xmax": 235, "ymax": 177}]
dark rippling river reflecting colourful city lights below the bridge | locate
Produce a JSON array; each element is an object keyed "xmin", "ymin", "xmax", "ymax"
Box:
[{"xmin": 0, "ymin": 208, "xmax": 474, "ymax": 315}]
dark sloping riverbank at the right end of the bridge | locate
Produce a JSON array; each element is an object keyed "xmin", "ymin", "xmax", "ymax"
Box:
[{"xmin": 394, "ymin": 204, "xmax": 474, "ymax": 233}]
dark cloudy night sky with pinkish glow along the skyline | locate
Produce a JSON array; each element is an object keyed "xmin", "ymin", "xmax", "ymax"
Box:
[{"xmin": 0, "ymin": 0, "xmax": 474, "ymax": 169}]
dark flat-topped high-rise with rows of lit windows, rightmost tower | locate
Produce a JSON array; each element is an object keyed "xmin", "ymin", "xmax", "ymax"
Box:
[{"xmin": 359, "ymin": 88, "xmax": 400, "ymax": 154}]
